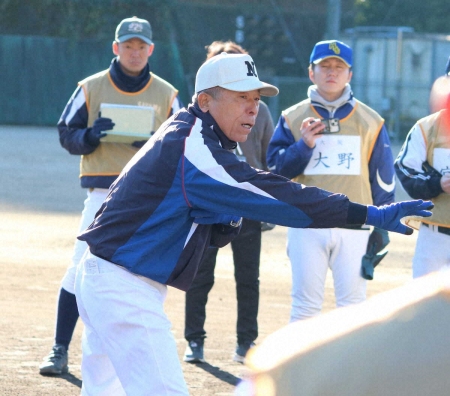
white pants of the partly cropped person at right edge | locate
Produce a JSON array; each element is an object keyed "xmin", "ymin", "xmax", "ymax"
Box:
[{"xmin": 413, "ymin": 224, "xmax": 450, "ymax": 278}]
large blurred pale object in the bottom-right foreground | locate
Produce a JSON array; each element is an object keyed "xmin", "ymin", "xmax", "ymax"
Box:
[{"xmin": 241, "ymin": 270, "xmax": 450, "ymax": 396}]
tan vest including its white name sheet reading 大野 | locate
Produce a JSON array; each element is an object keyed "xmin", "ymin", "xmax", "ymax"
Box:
[{"xmin": 282, "ymin": 99, "xmax": 384, "ymax": 204}]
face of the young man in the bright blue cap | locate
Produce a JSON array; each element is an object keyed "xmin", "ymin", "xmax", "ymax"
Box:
[{"xmin": 309, "ymin": 58, "xmax": 352, "ymax": 102}]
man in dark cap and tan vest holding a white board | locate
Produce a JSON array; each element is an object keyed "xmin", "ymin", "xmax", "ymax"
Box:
[{"xmin": 39, "ymin": 17, "xmax": 182, "ymax": 375}]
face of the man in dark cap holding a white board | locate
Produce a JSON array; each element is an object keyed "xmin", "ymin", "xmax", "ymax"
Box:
[{"xmin": 113, "ymin": 38, "xmax": 155, "ymax": 76}]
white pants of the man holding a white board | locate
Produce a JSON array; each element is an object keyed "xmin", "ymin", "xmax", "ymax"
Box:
[{"xmin": 61, "ymin": 188, "xmax": 109, "ymax": 294}]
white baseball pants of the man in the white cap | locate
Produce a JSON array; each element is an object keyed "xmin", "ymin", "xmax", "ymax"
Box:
[{"xmin": 75, "ymin": 250, "xmax": 188, "ymax": 396}]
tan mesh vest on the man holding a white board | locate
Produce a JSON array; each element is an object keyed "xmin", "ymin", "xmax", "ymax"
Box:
[{"xmin": 79, "ymin": 70, "xmax": 178, "ymax": 177}]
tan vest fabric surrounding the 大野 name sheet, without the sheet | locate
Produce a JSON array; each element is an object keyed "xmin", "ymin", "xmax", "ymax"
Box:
[{"xmin": 282, "ymin": 99, "xmax": 384, "ymax": 204}]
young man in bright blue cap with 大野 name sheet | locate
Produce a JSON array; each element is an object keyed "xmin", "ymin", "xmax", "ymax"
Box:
[{"xmin": 268, "ymin": 40, "xmax": 395, "ymax": 321}]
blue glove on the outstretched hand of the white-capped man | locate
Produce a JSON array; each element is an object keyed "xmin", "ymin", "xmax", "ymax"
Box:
[{"xmin": 366, "ymin": 199, "xmax": 434, "ymax": 235}]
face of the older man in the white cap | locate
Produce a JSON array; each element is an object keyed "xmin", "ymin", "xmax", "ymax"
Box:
[{"xmin": 199, "ymin": 89, "xmax": 261, "ymax": 142}]
